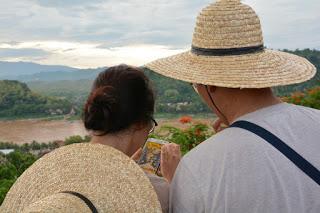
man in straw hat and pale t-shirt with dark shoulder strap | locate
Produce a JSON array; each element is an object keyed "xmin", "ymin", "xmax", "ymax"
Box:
[{"xmin": 147, "ymin": 0, "xmax": 320, "ymax": 213}]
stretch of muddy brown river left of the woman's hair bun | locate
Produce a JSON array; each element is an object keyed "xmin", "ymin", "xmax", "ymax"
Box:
[{"xmin": 0, "ymin": 120, "xmax": 88, "ymax": 144}]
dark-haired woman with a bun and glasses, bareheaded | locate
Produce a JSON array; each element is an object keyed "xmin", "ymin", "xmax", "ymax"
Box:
[{"xmin": 83, "ymin": 65, "xmax": 179, "ymax": 212}]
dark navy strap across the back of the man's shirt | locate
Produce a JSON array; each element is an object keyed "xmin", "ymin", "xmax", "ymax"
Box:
[{"xmin": 230, "ymin": 121, "xmax": 320, "ymax": 185}]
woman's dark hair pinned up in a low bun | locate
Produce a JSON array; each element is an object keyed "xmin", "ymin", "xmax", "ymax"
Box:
[{"xmin": 83, "ymin": 65, "xmax": 154, "ymax": 135}]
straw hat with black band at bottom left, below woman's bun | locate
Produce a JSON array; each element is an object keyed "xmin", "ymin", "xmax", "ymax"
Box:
[{"xmin": 1, "ymin": 144, "xmax": 161, "ymax": 213}]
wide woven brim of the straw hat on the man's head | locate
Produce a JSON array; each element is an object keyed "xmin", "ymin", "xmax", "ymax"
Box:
[{"xmin": 145, "ymin": 50, "xmax": 316, "ymax": 88}]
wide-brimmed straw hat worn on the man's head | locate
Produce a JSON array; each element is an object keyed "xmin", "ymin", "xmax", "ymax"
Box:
[{"xmin": 146, "ymin": 0, "xmax": 316, "ymax": 88}]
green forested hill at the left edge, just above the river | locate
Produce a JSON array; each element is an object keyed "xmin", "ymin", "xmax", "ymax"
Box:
[{"xmin": 0, "ymin": 80, "xmax": 72, "ymax": 119}]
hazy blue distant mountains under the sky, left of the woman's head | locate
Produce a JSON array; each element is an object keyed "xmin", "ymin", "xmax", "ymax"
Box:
[{"xmin": 0, "ymin": 61, "xmax": 103, "ymax": 82}]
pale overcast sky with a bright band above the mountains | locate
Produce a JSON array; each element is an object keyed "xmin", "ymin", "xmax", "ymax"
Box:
[{"xmin": 0, "ymin": 0, "xmax": 320, "ymax": 68}]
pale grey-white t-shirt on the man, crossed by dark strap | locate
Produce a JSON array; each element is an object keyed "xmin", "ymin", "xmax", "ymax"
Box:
[{"xmin": 170, "ymin": 103, "xmax": 320, "ymax": 213}]
